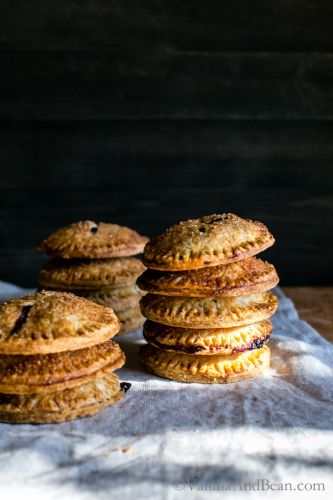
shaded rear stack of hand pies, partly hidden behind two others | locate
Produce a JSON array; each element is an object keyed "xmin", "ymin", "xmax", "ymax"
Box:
[{"xmin": 38, "ymin": 221, "xmax": 147, "ymax": 333}]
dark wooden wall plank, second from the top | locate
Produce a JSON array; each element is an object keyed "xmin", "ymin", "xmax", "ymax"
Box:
[{"xmin": 0, "ymin": 50, "xmax": 333, "ymax": 120}]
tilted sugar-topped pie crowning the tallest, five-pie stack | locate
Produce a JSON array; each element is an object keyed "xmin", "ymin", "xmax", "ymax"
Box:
[{"xmin": 143, "ymin": 214, "xmax": 274, "ymax": 271}]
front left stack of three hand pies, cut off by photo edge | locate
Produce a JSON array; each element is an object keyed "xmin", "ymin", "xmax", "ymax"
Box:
[{"xmin": 0, "ymin": 291, "xmax": 129, "ymax": 423}]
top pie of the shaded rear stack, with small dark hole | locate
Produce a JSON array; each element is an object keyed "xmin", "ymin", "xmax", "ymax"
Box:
[{"xmin": 38, "ymin": 220, "xmax": 148, "ymax": 259}]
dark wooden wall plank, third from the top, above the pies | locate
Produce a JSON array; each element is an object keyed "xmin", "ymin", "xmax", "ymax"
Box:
[{"xmin": 0, "ymin": 120, "xmax": 333, "ymax": 188}]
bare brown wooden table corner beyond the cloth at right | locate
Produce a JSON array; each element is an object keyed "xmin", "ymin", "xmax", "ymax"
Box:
[{"xmin": 283, "ymin": 287, "xmax": 333, "ymax": 342}]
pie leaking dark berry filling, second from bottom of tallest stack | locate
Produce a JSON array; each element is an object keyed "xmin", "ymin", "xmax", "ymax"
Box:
[{"xmin": 143, "ymin": 320, "xmax": 272, "ymax": 356}]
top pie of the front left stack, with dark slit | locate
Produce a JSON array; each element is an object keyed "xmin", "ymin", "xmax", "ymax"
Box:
[{"xmin": 0, "ymin": 291, "xmax": 120, "ymax": 354}]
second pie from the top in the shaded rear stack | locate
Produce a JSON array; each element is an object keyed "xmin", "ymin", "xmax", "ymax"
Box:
[{"xmin": 39, "ymin": 257, "xmax": 145, "ymax": 289}]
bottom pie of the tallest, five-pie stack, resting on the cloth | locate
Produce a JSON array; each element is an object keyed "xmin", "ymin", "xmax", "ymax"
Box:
[{"xmin": 140, "ymin": 344, "xmax": 270, "ymax": 384}]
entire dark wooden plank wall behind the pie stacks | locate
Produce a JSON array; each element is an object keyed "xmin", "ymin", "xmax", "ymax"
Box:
[{"xmin": 0, "ymin": 0, "xmax": 333, "ymax": 285}]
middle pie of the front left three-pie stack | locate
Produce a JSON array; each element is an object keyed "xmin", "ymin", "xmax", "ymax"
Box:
[{"xmin": 0, "ymin": 340, "xmax": 125, "ymax": 394}]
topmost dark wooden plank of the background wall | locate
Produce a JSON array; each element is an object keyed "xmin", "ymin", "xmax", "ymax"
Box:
[{"xmin": 0, "ymin": 0, "xmax": 333, "ymax": 53}]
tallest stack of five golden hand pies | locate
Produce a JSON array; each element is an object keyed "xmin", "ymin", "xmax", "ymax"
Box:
[{"xmin": 138, "ymin": 214, "xmax": 279, "ymax": 383}]
